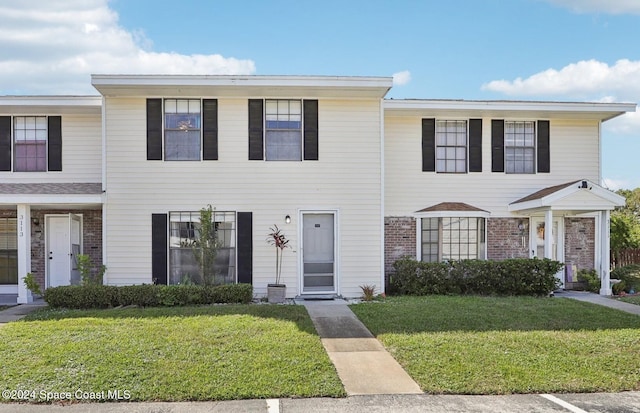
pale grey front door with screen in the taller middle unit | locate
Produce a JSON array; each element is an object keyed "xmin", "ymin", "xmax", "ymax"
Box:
[{"xmin": 302, "ymin": 212, "xmax": 336, "ymax": 294}]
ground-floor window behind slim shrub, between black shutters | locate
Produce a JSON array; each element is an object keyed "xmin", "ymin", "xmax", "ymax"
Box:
[{"xmin": 169, "ymin": 211, "xmax": 236, "ymax": 285}]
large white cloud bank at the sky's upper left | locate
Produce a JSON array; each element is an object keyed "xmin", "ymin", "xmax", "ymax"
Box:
[{"xmin": 0, "ymin": 0, "xmax": 255, "ymax": 94}]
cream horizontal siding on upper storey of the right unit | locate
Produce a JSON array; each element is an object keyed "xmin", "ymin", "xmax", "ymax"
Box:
[{"xmin": 384, "ymin": 113, "xmax": 600, "ymax": 217}]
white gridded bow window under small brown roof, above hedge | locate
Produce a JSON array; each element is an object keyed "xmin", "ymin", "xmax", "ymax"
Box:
[{"xmin": 420, "ymin": 217, "xmax": 486, "ymax": 262}]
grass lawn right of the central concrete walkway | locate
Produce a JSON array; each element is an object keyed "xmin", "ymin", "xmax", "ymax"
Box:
[{"xmin": 351, "ymin": 296, "xmax": 640, "ymax": 394}]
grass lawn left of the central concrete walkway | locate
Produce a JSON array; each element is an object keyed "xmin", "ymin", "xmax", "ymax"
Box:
[{"xmin": 0, "ymin": 305, "xmax": 345, "ymax": 401}]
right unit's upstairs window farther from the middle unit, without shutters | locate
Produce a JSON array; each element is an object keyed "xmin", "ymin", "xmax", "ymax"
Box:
[{"xmin": 504, "ymin": 121, "xmax": 536, "ymax": 174}]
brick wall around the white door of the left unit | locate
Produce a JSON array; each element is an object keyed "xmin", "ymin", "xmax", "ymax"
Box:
[{"xmin": 0, "ymin": 209, "xmax": 102, "ymax": 290}]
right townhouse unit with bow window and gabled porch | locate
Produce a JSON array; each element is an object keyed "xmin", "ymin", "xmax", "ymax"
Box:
[{"xmin": 384, "ymin": 100, "xmax": 635, "ymax": 294}]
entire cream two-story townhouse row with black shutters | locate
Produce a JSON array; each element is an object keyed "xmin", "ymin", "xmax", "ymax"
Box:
[{"xmin": 0, "ymin": 75, "xmax": 635, "ymax": 302}]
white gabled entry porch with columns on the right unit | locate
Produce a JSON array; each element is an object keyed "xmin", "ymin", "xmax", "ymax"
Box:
[{"xmin": 509, "ymin": 179, "xmax": 625, "ymax": 295}]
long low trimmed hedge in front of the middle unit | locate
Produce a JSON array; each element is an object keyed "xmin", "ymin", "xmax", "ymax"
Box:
[{"xmin": 44, "ymin": 284, "xmax": 253, "ymax": 309}]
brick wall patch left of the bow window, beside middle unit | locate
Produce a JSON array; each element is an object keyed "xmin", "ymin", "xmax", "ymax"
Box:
[{"xmin": 384, "ymin": 217, "xmax": 416, "ymax": 276}]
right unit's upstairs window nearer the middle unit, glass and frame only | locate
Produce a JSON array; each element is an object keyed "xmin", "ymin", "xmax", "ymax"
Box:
[{"xmin": 436, "ymin": 120, "xmax": 468, "ymax": 173}]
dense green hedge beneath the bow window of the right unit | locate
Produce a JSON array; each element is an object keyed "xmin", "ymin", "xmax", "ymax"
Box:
[{"xmin": 391, "ymin": 257, "xmax": 564, "ymax": 296}]
